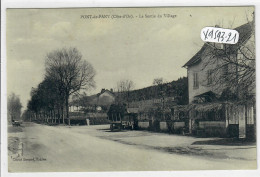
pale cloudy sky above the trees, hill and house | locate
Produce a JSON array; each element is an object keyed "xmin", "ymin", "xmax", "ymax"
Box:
[{"xmin": 6, "ymin": 7, "xmax": 254, "ymax": 110}]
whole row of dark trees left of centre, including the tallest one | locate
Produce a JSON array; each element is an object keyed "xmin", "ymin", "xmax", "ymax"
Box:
[{"xmin": 25, "ymin": 48, "xmax": 96, "ymax": 125}]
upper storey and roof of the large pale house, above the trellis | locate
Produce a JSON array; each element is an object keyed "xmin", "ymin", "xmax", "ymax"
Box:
[{"xmin": 183, "ymin": 22, "xmax": 255, "ymax": 103}]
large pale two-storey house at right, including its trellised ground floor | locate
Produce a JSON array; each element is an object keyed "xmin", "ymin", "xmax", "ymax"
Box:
[{"xmin": 183, "ymin": 20, "xmax": 256, "ymax": 138}]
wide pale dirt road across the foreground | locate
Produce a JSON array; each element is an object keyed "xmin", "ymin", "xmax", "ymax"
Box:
[{"xmin": 8, "ymin": 123, "xmax": 256, "ymax": 172}]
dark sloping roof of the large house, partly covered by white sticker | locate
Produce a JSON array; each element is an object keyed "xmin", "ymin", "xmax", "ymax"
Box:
[{"xmin": 183, "ymin": 22, "xmax": 254, "ymax": 67}]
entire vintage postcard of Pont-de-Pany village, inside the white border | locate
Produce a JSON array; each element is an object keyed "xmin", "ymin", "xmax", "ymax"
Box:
[{"xmin": 6, "ymin": 6, "xmax": 257, "ymax": 173}]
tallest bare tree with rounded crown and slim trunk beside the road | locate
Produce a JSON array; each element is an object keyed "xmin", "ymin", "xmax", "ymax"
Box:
[{"xmin": 45, "ymin": 48, "xmax": 96, "ymax": 125}]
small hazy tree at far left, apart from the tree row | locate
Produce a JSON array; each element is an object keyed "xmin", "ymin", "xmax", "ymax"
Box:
[{"xmin": 7, "ymin": 93, "xmax": 22, "ymax": 122}]
